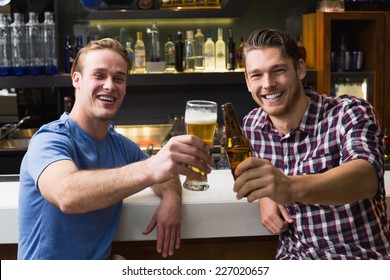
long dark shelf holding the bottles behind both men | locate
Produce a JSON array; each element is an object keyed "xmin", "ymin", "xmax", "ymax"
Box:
[{"xmin": 0, "ymin": 70, "xmax": 317, "ymax": 89}]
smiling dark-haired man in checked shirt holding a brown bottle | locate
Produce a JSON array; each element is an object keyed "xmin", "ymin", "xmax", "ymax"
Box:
[{"xmin": 234, "ymin": 30, "xmax": 390, "ymax": 259}]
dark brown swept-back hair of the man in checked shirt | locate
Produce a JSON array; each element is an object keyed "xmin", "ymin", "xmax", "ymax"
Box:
[{"xmin": 244, "ymin": 29, "xmax": 300, "ymax": 68}]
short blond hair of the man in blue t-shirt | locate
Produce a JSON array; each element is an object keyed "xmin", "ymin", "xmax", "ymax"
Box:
[{"xmin": 70, "ymin": 38, "xmax": 130, "ymax": 74}]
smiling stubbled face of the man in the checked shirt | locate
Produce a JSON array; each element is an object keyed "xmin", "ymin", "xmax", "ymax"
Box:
[{"xmin": 245, "ymin": 47, "xmax": 308, "ymax": 131}]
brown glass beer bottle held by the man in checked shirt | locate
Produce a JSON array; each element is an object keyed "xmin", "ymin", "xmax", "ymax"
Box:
[{"xmin": 222, "ymin": 102, "xmax": 252, "ymax": 180}]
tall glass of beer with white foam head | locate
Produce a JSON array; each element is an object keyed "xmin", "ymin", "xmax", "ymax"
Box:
[{"xmin": 183, "ymin": 100, "xmax": 217, "ymax": 191}]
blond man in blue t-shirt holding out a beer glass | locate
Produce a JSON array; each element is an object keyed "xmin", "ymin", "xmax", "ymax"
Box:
[{"xmin": 18, "ymin": 39, "xmax": 212, "ymax": 259}]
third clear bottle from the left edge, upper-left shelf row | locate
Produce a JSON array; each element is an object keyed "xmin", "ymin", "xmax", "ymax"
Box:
[{"xmin": 26, "ymin": 12, "xmax": 43, "ymax": 75}]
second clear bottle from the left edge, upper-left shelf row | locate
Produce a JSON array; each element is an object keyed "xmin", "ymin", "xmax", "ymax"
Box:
[{"xmin": 11, "ymin": 13, "xmax": 27, "ymax": 75}]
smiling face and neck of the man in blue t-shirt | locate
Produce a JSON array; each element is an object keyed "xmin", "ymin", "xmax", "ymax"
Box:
[{"xmin": 70, "ymin": 49, "xmax": 127, "ymax": 135}]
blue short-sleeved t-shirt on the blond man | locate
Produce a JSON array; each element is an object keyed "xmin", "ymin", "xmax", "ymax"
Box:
[{"xmin": 18, "ymin": 114, "xmax": 148, "ymax": 259}]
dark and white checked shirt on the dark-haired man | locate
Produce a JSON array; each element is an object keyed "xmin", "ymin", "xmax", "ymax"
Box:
[{"xmin": 243, "ymin": 90, "xmax": 390, "ymax": 259}]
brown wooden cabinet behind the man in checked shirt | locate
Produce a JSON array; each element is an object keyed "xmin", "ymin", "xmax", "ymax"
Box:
[{"xmin": 302, "ymin": 12, "xmax": 390, "ymax": 128}]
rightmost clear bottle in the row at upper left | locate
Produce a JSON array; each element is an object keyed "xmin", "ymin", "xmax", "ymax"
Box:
[{"xmin": 42, "ymin": 12, "xmax": 58, "ymax": 75}]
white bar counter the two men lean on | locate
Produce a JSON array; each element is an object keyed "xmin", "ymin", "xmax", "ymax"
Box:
[{"xmin": 0, "ymin": 170, "xmax": 390, "ymax": 243}]
